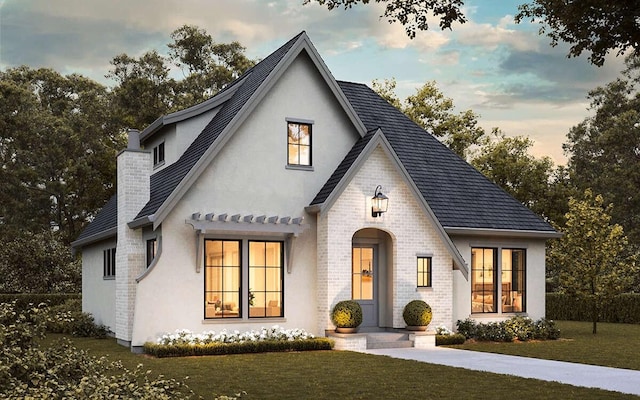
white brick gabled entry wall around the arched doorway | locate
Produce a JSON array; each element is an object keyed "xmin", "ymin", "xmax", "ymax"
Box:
[{"xmin": 317, "ymin": 147, "xmax": 458, "ymax": 330}]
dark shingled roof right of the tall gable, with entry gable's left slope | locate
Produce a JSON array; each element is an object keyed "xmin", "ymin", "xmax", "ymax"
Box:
[{"xmin": 311, "ymin": 82, "xmax": 555, "ymax": 232}]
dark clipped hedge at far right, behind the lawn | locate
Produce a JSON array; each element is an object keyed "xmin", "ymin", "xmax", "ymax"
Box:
[{"xmin": 546, "ymin": 293, "xmax": 640, "ymax": 324}]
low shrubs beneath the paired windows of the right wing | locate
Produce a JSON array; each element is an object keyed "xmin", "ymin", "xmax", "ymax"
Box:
[{"xmin": 456, "ymin": 316, "xmax": 560, "ymax": 342}]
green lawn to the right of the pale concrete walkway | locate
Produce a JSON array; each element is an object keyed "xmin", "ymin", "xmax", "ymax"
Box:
[{"xmin": 451, "ymin": 321, "xmax": 640, "ymax": 370}]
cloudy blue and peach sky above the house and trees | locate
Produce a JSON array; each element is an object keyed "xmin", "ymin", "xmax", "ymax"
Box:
[{"xmin": 0, "ymin": 0, "xmax": 623, "ymax": 164}]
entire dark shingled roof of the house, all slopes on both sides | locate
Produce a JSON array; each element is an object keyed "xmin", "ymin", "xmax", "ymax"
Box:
[{"xmin": 76, "ymin": 32, "xmax": 555, "ymax": 245}]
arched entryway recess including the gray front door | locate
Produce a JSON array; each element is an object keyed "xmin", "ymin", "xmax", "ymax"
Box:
[{"xmin": 351, "ymin": 228, "xmax": 393, "ymax": 330}]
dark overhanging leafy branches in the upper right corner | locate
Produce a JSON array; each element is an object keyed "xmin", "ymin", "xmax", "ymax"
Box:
[{"xmin": 516, "ymin": 0, "xmax": 640, "ymax": 66}]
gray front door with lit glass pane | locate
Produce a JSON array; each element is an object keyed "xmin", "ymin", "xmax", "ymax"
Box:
[{"xmin": 351, "ymin": 245, "xmax": 378, "ymax": 328}]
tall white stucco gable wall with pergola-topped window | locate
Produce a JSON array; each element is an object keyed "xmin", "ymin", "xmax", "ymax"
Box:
[{"xmin": 127, "ymin": 51, "xmax": 359, "ymax": 346}]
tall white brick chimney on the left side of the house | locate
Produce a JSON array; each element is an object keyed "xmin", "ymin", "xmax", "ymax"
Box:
[{"xmin": 115, "ymin": 129, "xmax": 153, "ymax": 346}]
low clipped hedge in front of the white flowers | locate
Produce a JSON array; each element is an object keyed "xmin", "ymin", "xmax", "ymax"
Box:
[{"xmin": 144, "ymin": 338, "xmax": 333, "ymax": 357}]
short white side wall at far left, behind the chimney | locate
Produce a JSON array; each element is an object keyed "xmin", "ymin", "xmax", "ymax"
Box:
[{"xmin": 82, "ymin": 239, "xmax": 117, "ymax": 331}]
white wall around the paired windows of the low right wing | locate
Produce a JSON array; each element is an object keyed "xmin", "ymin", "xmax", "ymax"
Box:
[{"xmin": 452, "ymin": 236, "xmax": 546, "ymax": 323}]
